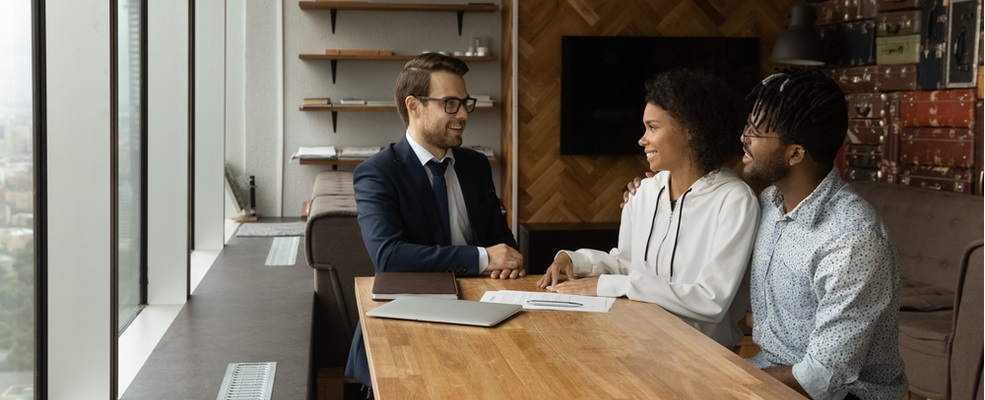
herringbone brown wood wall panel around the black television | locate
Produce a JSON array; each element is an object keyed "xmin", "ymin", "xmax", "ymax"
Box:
[{"xmin": 502, "ymin": 0, "xmax": 800, "ymax": 223}]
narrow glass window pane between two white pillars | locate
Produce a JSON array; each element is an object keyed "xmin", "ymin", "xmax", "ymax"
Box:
[{"xmin": 117, "ymin": 0, "xmax": 143, "ymax": 332}]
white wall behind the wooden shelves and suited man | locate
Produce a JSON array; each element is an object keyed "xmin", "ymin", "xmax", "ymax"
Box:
[{"xmin": 237, "ymin": 0, "xmax": 502, "ymax": 216}]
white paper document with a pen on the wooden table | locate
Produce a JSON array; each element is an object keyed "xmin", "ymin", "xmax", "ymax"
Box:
[{"xmin": 479, "ymin": 290, "xmax": 616, "ymax": 312}]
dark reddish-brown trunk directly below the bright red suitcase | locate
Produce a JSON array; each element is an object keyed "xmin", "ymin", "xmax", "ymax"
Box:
[{"xmin": 899, "ymin": 128, "xmax": 977, "ymax": 168}]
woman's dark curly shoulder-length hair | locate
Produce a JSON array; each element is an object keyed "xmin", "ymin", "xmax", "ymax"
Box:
[{"xmin": 644, "ymin": 69, "xmax": 746, "ymax": 173}]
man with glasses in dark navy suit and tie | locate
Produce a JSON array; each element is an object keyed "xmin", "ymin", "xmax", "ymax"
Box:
[{"xmin": 346, "ymin": 53, "xmax": 525, "ymax": 386}]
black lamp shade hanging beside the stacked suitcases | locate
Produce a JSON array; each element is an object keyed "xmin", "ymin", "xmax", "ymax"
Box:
[{"xmin": 773, "ymin": 5, "xmax": 824, "ymax": 66}]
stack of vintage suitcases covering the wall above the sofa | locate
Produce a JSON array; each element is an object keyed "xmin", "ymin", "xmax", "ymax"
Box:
[{"xmin": 814, "ymin": 0, "xmax": 983, "ymax": 194}]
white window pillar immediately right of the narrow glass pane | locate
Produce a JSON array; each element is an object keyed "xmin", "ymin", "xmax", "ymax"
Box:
[{"xmin": 147, "ymin": 0, "xmax": 190, "ymax": 304}]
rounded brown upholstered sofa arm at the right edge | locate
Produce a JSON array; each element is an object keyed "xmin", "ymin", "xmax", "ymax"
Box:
[{"xmin": 945, "ymin": 240, "xmax": 985, "ymax": 399}]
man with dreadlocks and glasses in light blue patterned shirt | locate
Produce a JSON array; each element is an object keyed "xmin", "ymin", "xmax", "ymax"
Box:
[{"xmin": 741, "ymin": 69, "xmax": 907, "ymax": 399}]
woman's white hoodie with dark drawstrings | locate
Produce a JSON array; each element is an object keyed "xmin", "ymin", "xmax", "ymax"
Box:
[{"xmin": 564, "ymin": 168, "xmax": 760, "ymax": 348}]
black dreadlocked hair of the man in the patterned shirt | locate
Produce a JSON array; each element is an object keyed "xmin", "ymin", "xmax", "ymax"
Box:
[{"xmin": 748, "ymin": 68, "xmax": 848, "ymax": 167}]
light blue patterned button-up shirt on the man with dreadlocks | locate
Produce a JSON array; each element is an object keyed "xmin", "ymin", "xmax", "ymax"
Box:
[{"xmin": 749, "ymin": 169, "xmax": 907, "ymax": 399}]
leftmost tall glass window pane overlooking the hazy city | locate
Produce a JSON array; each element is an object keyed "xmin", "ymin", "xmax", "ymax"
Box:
[{"xmin": 0, "ymin": 0, "xmax": 36, "ymax": 399}]
